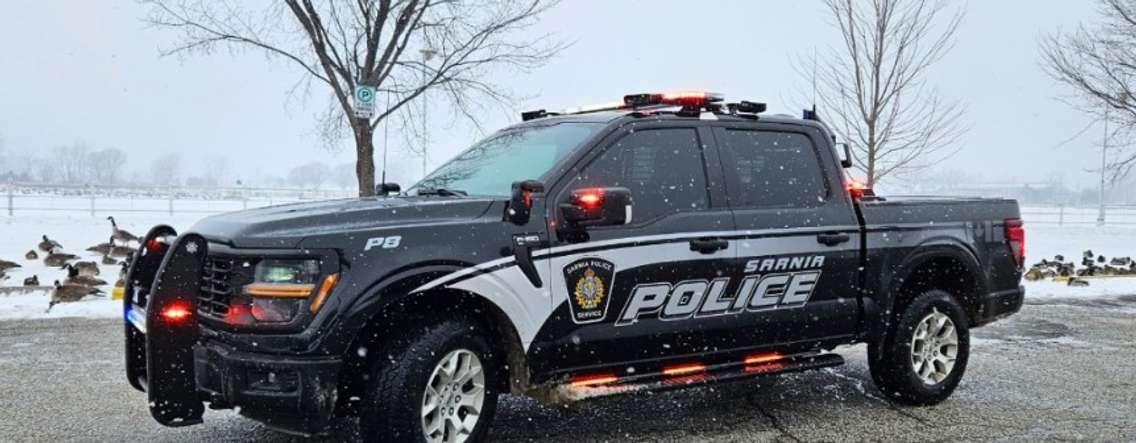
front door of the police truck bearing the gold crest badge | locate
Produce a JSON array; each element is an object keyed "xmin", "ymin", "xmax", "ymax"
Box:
[{"xmin": 529, "ymin": 120, "xmax": 736, "ymax": 373}]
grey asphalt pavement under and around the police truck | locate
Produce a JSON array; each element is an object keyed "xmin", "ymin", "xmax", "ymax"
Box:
[{"xmin": 0, "ymin": 295, "xmax": 1136, "ymax": 442}]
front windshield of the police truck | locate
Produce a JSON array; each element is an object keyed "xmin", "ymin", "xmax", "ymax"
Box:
[{"xmin": 407, "ymin": 122, "xmax": 603, "ymax": 197}]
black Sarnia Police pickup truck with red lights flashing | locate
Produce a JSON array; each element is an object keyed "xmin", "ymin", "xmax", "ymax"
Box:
[{"xmin": 124, "ymin": 93, "xmax": 1025, "ymax": 442}]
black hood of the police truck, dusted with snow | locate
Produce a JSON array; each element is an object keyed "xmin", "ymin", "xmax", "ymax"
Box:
[{"xmin": 190, "ymin": 197, "xmax": 493, "ymax": 248}]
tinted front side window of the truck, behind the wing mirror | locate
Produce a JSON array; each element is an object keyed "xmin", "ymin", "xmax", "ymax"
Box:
[{"xmin": 570, "ymin": 128, "xmax": 710, "ymax": 224}]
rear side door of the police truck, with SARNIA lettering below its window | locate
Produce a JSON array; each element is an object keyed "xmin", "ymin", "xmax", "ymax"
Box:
[{"xmin": 715, "ymin": 124, "xmax": 860, "ymax": 343}]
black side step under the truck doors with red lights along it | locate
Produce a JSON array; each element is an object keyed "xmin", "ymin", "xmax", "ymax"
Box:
[{"xmin": 554, "ymin": 352, "xmax": 844, "ymax": 401}]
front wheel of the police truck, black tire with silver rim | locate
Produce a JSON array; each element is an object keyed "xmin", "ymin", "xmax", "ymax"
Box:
[{"xmin": 359, "ymin": 319, "xmax": 498, "ymax": 442}]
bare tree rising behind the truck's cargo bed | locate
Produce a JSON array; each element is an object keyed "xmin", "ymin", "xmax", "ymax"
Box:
[{"xmin": 797, "ymin": 0, "xmax": 966, "ymax": 185}]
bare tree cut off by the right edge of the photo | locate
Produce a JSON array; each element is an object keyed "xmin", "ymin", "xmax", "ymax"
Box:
[{"xmin": 1042, "ymin": 0, "xmax": 1136, "ymax": 183}]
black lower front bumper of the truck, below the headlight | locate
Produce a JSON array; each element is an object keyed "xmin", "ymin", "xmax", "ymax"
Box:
[{"xmin": 193, "ymin": 342, "xmax": 342, "ymax": 434}]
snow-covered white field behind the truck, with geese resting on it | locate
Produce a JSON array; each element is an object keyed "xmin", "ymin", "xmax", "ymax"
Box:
[{"xmin": 0, "ymin": 204, "xmax": 1136, "ymax": 320}]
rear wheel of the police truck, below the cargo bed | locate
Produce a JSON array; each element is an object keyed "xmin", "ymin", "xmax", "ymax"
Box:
[{"xmin": 868, "ymin": 290, "xmax": 970, "ymax": 406}]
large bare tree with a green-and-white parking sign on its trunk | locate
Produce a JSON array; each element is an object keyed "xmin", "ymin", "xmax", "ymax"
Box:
[{"xmin": 149, "ymin": 0, "xmax": 563, "ymax": 195}]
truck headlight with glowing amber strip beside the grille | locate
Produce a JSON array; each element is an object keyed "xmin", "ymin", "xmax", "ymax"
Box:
[{"xmin": 231, "ymin": 259, "xmax": 339, "ymax": 324}]
